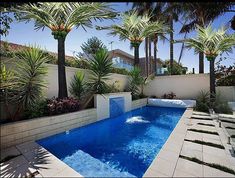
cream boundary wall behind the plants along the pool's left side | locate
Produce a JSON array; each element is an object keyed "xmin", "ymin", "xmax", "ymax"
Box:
[{"xmin": 45, "ymin": 64, "xmax": 128, "ymax": 98}]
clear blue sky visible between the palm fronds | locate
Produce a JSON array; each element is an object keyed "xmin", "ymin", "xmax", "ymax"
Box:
[{"xmin": 2, "ymin": 2, "xmax": 235, "ymax": 73}]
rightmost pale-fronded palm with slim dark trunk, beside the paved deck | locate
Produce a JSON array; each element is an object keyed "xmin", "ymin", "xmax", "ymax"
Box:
[{"xmin": 185, "ymin": 25, "xmax": 235, "ymax": 101}]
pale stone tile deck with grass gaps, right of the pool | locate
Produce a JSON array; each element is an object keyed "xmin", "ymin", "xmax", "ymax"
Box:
[{"xmin": 143, "ymin": 109, "xmax": 235, "ymax": 177}]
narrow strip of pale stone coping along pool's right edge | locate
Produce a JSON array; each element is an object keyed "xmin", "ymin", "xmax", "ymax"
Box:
[{"xmin": 143, "ymin": 108, "xmax": 193, "ymax": 177}]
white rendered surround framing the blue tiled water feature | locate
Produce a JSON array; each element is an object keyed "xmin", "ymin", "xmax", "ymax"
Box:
[{"xmin": 95, "ymin": 92, "xmax": 132, "ymax": 120}]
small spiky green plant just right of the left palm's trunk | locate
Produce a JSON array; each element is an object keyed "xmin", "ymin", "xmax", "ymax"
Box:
[{"xmin": 69, "ymin": 71, "xmax": 86, "ymax": 100}]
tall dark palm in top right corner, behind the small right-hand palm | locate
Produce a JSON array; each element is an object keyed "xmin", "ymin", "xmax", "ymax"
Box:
[{"xmin": 180, "ymin": 2, "xmax": 233, "ymax": 73}]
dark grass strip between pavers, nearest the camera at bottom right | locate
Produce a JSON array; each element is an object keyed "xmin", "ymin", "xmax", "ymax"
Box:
[{"xmin": 179, "ymin": 155, "xmax": 235, "ymax": 175}]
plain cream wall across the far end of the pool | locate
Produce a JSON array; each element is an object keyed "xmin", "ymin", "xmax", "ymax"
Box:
[{"xmin": 144, "ymin": 74, "xmax": 210, "ymax": 99}]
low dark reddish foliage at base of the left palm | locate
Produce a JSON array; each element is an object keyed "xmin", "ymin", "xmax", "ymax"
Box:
[{"xmin": 46, "ymin": 97, "xmax": 80, "ymax": 115}]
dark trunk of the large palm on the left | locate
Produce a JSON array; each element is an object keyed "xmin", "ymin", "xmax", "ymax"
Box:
[{"xmin": 58, "ymin": 38, "xmax": 68, "ymax": 98}]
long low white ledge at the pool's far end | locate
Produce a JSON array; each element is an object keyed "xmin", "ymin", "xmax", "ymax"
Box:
[{"xmin": 148, "ymin": 98, "xmax": 196, "ymax": 108}]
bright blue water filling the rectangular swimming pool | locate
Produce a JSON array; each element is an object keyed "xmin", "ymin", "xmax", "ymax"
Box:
[{"xmin": 37, "ymin": 106, "xmax": 185, "ymax": 177}]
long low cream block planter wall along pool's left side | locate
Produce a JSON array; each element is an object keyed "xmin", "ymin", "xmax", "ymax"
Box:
[{"xmin": 0, "ymin": 109, "xmax": 97, "ymax": 149}]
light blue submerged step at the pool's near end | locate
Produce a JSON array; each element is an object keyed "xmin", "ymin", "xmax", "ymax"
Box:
[{"xmin": 62, "ymin": 150, "xmax": 135, "ymax": 177}]
